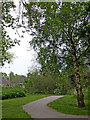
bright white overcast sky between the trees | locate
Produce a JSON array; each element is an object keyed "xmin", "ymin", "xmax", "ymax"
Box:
[{"xmin": 0, "ymin": 0, "xmax": 39, "ymax": 75}]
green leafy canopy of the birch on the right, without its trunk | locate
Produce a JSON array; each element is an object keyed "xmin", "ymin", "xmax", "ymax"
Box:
[{"xmin": 24, "ymin": 2, "xmax": 90, "ymax": 72}]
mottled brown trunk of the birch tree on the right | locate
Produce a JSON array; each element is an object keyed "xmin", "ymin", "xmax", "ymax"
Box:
[{"xmin": 68, "ymin": 28, "xmax": 85, "ymax": 107}]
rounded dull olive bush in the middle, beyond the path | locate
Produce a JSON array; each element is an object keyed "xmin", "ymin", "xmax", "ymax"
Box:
[{"xmin": 28, "ymin": 75, "xmax": 56, "ymax": 94}]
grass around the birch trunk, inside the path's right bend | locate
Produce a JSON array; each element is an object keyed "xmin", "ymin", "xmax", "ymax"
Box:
[{"xmin": 48, "ymin": 95, "xmax": 90, "ymax": 115}]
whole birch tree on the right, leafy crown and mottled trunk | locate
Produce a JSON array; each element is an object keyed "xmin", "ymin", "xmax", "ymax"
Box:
[{"xmin": 18, "ymin": 2, "xmax": 90, "ymax": 107}]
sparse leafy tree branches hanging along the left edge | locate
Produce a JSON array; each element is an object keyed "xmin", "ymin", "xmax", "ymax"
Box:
[{"xmin": 0, "ymin": 1, "xmax": 19, "ymax": 66}]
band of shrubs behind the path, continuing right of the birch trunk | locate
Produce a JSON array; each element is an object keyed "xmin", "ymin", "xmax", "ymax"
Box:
[{"xmin": 23, "ymin": 67, "xmax": 90, "ymax": 95}]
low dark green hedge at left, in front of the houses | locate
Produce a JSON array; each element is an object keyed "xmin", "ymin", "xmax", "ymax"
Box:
[{"xmin": 2, "ymin": 88, "xmax": 26, "ymax": 100}]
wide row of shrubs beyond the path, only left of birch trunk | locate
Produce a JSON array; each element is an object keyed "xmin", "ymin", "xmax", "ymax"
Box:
[{"xmin": 23, "ymin": 72, "xmax": 70, "ymax": 95}]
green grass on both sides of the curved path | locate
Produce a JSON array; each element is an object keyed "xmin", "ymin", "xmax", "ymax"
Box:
[{"xmin": 2, "ymin": 90, "xmax": 90, "ymax": 118}]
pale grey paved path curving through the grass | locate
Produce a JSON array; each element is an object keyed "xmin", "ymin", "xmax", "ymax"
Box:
[{"xmin": 23, "ymin": 96, "xmax": 88, "ymax": 118}]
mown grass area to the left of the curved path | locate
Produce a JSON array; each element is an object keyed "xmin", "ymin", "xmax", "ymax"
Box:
[{"xmin": 2, "ymin": 95, "xmax": 48, "ymax": 118}]
